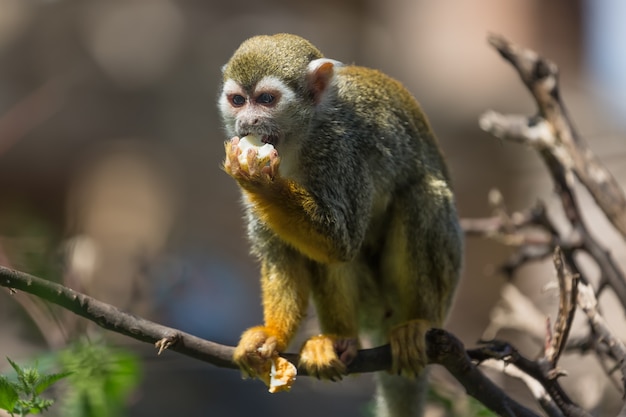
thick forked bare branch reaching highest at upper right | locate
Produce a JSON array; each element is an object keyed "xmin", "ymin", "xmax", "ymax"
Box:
[{"xmin": 480, "ymin": 35, "xmax": 626, "ymax": 309}]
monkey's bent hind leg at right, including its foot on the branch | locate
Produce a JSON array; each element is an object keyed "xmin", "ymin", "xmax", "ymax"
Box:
[{"xmin": 382, "ymin": 195, "xmax": 461, "ymax": 377}]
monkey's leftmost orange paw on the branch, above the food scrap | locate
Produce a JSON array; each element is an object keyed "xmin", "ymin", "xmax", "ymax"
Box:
[{"xmin": 233, "ymin": 326, "xmax": 285, "ymax": 381}]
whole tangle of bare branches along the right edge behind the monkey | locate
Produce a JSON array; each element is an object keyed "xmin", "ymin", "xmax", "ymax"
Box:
[{"xmin": 470, "ymin": 35, "xmax": 626, "ymax": 416}]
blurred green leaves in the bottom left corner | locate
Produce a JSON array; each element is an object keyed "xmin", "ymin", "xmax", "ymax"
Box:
[{"xmin": 0, "ymin": 339, "xmax": 141, "ymax": 417}]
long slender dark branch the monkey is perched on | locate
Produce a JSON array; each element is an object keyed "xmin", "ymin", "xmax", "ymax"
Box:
[{"xmin": 0, "ymin": 266, "xmax": 536, "ymax": 417}]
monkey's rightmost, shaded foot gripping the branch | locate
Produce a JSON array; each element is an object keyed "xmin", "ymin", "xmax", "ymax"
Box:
[{"xmin": 389, "ymin": 319, "xmax": 432, "ymax": 378}]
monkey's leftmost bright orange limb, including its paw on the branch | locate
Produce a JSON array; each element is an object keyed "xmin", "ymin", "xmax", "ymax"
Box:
[{"xmin": 233, "ymin": 258, "xmax": 309, "ymax": 377}]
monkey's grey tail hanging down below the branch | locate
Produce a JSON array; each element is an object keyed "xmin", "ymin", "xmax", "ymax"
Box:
[{"xmin": 375, "ymin": 370, "xmax": 428, "ymax": 417}]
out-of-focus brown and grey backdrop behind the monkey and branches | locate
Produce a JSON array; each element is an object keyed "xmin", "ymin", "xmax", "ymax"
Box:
[{"xmin": 0, "ymin": 0, "xmax": 626, "ymax": 417}]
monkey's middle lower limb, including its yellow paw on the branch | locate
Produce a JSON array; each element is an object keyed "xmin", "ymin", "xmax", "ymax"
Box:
[{"xmin": 300, "ymin": 263, "xmax": 359, "ymax": 381}]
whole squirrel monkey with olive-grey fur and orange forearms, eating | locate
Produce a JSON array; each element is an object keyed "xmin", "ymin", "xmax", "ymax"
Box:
[{"xmin": 218, "ymin": 34, "xmax": 463, "ymax": 417}]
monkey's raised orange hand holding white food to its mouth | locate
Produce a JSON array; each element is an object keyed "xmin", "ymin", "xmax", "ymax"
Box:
[{"xmin": 224, "ymin": 136, "xmax": 280, "ymax": 187}]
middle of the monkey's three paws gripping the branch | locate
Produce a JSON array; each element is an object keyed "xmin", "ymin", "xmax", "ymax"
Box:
[{"xmin": 300, "ymin": 335, "xmax": 359, "ymax": 381}]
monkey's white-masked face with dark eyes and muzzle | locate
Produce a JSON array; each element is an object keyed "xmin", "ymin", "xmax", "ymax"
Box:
[{"xmin": 219, "ymin": 76, "xmax": 297, "ymax": 148}]
